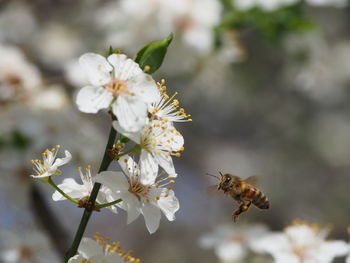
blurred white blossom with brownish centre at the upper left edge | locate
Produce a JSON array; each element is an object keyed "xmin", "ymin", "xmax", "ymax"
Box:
[{"xmin": 0, "ymin": 44, "xmax": 42, "ymax": 103}]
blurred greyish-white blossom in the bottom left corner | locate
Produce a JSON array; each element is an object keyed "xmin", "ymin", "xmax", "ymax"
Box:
[{"xmin": 0, "ymin": 228, "xmax": 60, "ymax": 263}]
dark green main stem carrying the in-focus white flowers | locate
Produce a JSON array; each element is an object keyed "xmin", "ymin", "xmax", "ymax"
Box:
[{"xmin": 65, "ymin": 116, "xmax": 119, "ymax": 263}]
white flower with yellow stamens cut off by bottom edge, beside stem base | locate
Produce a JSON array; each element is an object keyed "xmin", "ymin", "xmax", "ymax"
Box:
[{"xmin": 68, "ymin": 233, "xmax": 141, "ymax": 263}]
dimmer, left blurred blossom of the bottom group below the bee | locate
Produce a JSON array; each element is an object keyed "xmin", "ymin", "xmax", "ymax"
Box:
[{"xmin": 199, "ymin": 224, "xmax": 268, "ymax": 262}]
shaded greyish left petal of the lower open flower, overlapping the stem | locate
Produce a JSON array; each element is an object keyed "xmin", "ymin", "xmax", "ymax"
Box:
[{"xmin": 95, "ymin": 171, "xmax": 129, "ymax": 192}]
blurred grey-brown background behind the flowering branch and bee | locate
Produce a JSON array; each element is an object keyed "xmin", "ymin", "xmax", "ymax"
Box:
[{"xmin": 0, "ymin": 0, "xmax": 350, "ymax": 263}]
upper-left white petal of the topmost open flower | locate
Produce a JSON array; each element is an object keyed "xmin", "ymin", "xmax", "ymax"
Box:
[{"xmin": 79, "ymin": 53, "xmax": 113, "ymax": 86}]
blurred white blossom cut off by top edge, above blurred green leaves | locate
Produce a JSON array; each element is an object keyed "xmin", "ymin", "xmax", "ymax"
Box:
[{"xmin": 233, "ymin": 0, "xmax": 299, "ymax": 11}]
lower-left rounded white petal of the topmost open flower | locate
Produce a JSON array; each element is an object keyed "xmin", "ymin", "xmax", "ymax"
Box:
[{"xmin": 76, "ymin": 86, "xmax": 113, "ymax": 113}]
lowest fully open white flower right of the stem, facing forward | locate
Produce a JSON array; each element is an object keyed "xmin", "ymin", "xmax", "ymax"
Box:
[{"xmin": 96, "ymin": 156, "xmax": 179, "ymax": 234}]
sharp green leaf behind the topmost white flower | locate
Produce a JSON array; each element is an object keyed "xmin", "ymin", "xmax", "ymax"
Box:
[{"xmin": 135, "ymin": 33, "xmax": 173, "ymax": 74}]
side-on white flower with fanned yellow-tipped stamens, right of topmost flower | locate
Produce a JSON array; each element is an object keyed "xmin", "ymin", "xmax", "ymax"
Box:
[{"xmin": 148, "ymin": 79, "xmax": 192, "ymax": 122}]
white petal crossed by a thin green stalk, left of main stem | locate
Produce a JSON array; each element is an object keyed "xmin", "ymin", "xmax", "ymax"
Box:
[{"xmin": 52, "ymin": 178, "xmax": 89, "ymax": 201}]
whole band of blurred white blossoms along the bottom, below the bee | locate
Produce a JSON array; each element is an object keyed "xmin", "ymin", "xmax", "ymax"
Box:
[{"xmin": 199, "ymin": 220, "xmax": 350, "ymax": 263}]
